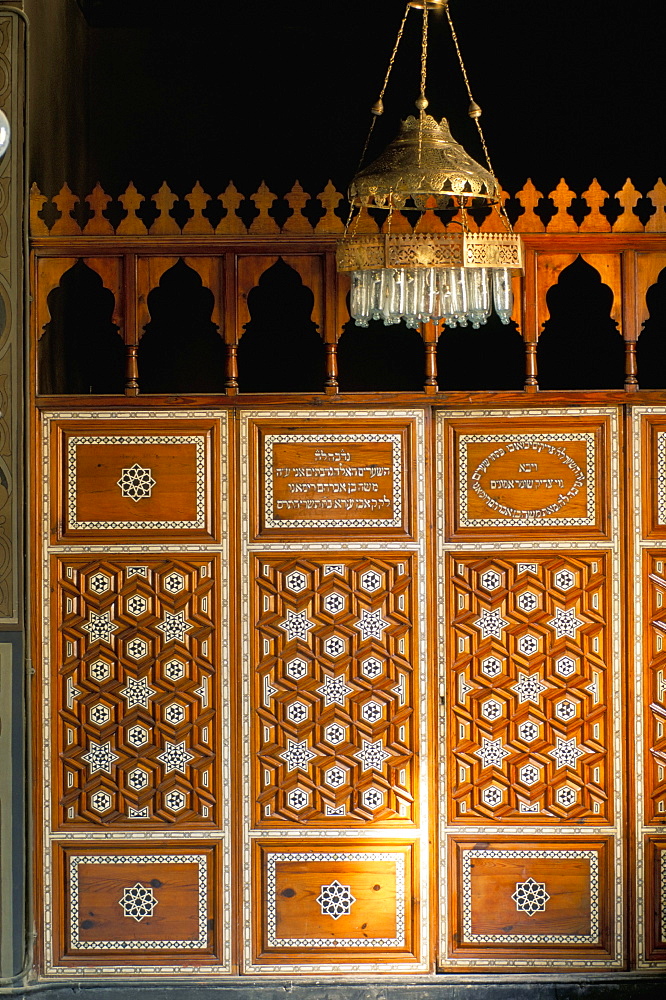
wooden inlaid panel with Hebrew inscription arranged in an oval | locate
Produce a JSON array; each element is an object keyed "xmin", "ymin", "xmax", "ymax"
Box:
[{"xmin": 439, "ymin": 413, "xmax": 608, "ymax": 539}]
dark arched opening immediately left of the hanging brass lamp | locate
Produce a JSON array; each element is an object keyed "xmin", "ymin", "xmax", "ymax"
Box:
[{"xmin": 238, "ymin": 257, "xmax": 324, "ymax": 392}]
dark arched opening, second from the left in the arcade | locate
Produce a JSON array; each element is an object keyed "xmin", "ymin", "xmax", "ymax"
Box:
[{"xmin": 137, "ymin": 258, "xmax": 225, "ymax": 393}]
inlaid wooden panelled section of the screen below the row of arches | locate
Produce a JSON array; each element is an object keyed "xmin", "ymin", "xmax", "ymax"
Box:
[{"xmin": 36, "ymin": 406, "xmax": 666, "ymax": 976}]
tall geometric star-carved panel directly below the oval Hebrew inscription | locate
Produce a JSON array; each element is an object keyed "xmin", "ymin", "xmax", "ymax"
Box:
[{"xmin": 446, "ymin": 550, "xmax": 614, "ymax": 825}]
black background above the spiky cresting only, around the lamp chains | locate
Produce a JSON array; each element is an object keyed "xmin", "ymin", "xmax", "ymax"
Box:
[{"xmin": 32, "ymin": 0, "xmax": 666, "ymax": 201}]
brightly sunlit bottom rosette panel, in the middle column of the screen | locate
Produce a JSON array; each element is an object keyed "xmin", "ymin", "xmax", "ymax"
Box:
[{"xmin": 253, "ymin": 840, "xmax": 419, "ymax": 971}]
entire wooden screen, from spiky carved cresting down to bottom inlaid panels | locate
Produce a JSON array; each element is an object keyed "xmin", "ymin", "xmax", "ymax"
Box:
[{"xmin": 30, "ymin": 182, "xmax": 666, "ymax": 981}]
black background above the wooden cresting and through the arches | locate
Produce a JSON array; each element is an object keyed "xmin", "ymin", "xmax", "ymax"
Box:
[{"xmin": 24, "ymin": 0, "xmax": 666, "ymax": 392}]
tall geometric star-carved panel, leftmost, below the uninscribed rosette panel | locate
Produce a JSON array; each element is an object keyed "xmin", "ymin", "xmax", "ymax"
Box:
[{"xmin": 52, "ymin": 552, "xmax": 220, "ymax": 829}]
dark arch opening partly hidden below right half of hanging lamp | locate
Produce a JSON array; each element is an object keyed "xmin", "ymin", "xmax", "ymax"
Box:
[{"xmin": 437, "ymin": 313, "xmax": 525, "ymax": 392}]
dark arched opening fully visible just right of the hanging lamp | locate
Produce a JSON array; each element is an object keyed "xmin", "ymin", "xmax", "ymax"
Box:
[{"xmin": 537, "ymin": 256, "xmax": 625, "ymax": 389}]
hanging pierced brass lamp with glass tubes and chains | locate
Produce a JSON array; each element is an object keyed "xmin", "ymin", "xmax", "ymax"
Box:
[{"xmin": 337, "ymin": 0, "xmax": 522, "ymax": 328}]
